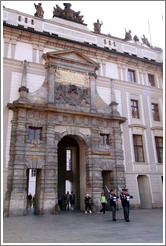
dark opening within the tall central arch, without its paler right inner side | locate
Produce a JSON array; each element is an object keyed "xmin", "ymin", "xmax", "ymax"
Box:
[{"xmin": 58, "ymin": 135, "xmax": 80, "ymax": 210}]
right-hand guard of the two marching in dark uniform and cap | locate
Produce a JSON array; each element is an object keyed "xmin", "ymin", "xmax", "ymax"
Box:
[{"xmin": 120, "ymin": 189, "xmax": 133, "ymax": 222}]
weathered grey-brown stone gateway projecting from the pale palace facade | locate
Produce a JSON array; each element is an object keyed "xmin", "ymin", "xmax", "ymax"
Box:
[{"xmin": 5, "ymin": 50, "xmax": 125, "ymax": 215}]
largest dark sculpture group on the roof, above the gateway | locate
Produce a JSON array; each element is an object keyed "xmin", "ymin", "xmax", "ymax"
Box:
[{"xmin": 53, "ymin": 3, "xmax": 84, "ymax": 23}]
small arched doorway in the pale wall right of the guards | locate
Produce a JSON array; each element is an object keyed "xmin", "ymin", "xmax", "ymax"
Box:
[{"xmin": 137, "ymin": 175, "xmax": 152, "ymax": 208}]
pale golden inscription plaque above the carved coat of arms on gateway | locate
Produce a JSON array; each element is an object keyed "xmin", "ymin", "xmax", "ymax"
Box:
[{"xmin": 57, "ymin": 68, "xmax": 89, "ymax": 87}]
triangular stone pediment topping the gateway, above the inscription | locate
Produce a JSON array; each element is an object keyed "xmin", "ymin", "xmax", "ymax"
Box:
[{"xmin": 43, "ymin": 50, "xmax": 99, "ymax": 67}]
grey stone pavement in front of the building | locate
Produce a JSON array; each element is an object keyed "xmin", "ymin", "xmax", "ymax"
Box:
[{"xmin": 3, "ymin": 209, "xmax": 163, "ymax": 244}]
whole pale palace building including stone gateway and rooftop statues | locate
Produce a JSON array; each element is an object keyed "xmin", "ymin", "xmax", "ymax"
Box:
[{"xmin": 3, "ymin": 2, "xmax": 163, "ymax": 216}]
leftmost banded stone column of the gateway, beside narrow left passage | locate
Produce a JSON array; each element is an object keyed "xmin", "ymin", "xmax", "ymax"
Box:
[{"xmin": 8, "ymin": 109, "xmax": 27, "ymax": 216}]
